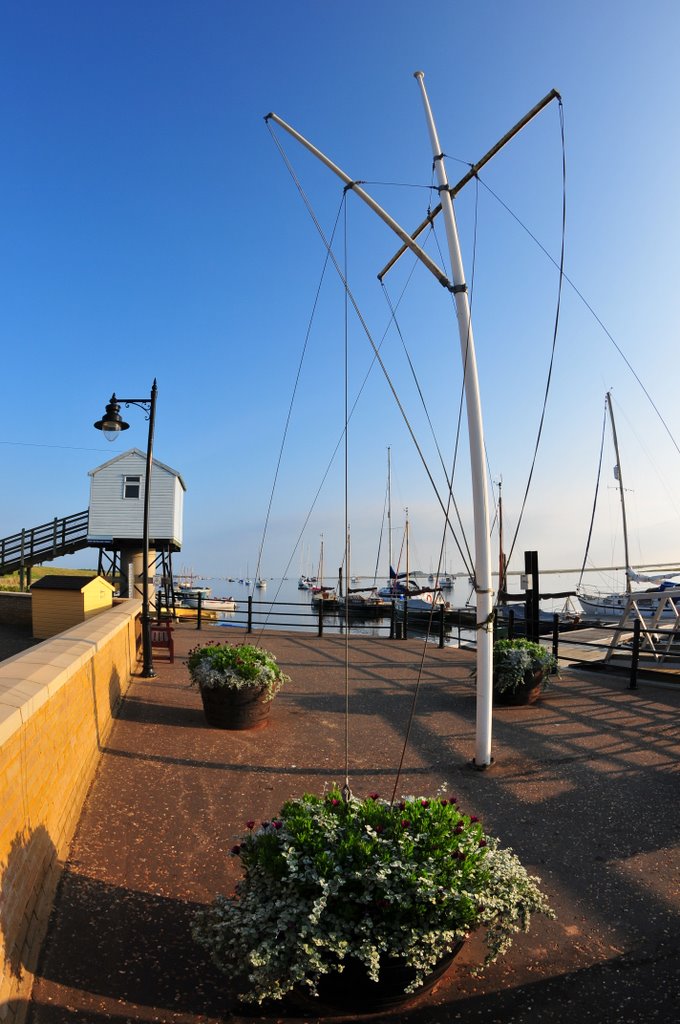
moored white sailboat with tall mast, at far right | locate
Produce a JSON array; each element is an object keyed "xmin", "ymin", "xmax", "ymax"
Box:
[{"xmin": 577, "ymin": 391, "xmax": 680, "ymax": 622}]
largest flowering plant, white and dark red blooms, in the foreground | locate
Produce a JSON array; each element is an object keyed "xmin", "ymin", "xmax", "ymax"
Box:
[{"xmin": 193, "ymin": 788, "xmax": 553, "ymax": 1002}]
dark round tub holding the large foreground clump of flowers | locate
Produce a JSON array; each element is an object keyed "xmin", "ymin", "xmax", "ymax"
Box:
[{"xmin": 289, "ymin": 942, "xmax": 463, "ymax": 1016}]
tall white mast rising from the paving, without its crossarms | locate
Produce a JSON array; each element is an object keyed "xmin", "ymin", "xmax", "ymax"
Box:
[{"xmin": 414, "ymin": 71, "xmax": 494, "ymax": 768}]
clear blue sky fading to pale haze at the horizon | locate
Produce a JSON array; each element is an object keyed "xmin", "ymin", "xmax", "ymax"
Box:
[{"xmin": 0, "ymin": 0, "xmax": 680, "ymax": 593}]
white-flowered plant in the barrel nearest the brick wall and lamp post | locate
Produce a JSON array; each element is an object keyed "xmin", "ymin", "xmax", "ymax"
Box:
[{"xmin": 186, "ymin": 643, "xmax": 290, "ymax": 700}]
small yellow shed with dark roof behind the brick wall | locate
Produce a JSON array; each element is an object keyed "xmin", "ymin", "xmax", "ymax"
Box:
[{"xmin": 31, "ymin": 575, "xmax": 114, "ymax": 640}]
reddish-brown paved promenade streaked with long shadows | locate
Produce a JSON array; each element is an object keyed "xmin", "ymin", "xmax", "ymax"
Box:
[{"xmin": 23, "ymin": 625, "xmax": 680, "ymax": 1024}]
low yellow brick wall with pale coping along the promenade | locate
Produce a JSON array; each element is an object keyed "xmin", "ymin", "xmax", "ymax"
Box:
[{"xmin": 0, "ymin": 600, "xmax": 139, "ymax": 1024}]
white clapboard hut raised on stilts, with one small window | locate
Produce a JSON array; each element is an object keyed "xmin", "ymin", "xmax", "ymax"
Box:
[{"xmin": 87, "ymin": 449, "xmax": 186, "ymax": 551}]
